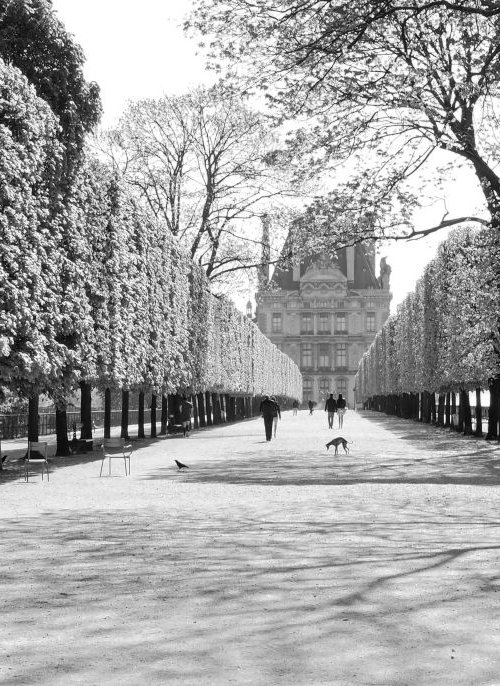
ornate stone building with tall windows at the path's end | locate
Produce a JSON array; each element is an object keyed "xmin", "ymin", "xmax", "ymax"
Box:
[{"xmin": 256, "ymin": 244, "xmax": 392, "ymax": 407}]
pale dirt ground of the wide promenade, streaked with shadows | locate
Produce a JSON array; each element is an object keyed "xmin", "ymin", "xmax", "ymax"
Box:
[{"xmin": 0, "ymin": 411, "xmax": 500, "ymax": 686}]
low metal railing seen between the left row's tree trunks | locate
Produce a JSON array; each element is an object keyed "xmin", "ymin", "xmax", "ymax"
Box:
[{"xmin": 0, "ymin": 410, "xmax": 141, "ymax": 440}]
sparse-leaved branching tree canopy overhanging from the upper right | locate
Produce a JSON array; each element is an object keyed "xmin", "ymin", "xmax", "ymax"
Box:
[{"xmin": 187, "ymin": 0, "xmax": 500, "ymax": 247}]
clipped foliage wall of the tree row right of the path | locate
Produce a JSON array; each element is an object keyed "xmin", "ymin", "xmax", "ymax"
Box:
[{"xmin": 356, "ymin": 228, "xmax": 500, "ymax": 400}]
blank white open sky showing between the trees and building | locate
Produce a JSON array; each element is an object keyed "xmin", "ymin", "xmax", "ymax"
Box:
[{"xmin": 52, "ymin": 0, "xmax": 484, "ymax": 311}]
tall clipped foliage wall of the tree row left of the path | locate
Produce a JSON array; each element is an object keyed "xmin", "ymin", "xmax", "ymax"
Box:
[{"xmin": 0, "ymin": 61, "xmax": 301, "ymax": 404}]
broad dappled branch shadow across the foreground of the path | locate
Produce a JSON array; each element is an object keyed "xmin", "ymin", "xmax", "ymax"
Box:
[{"xmin": 2, "ymin": 506, "xmax": 500, "ymax": 684}]
